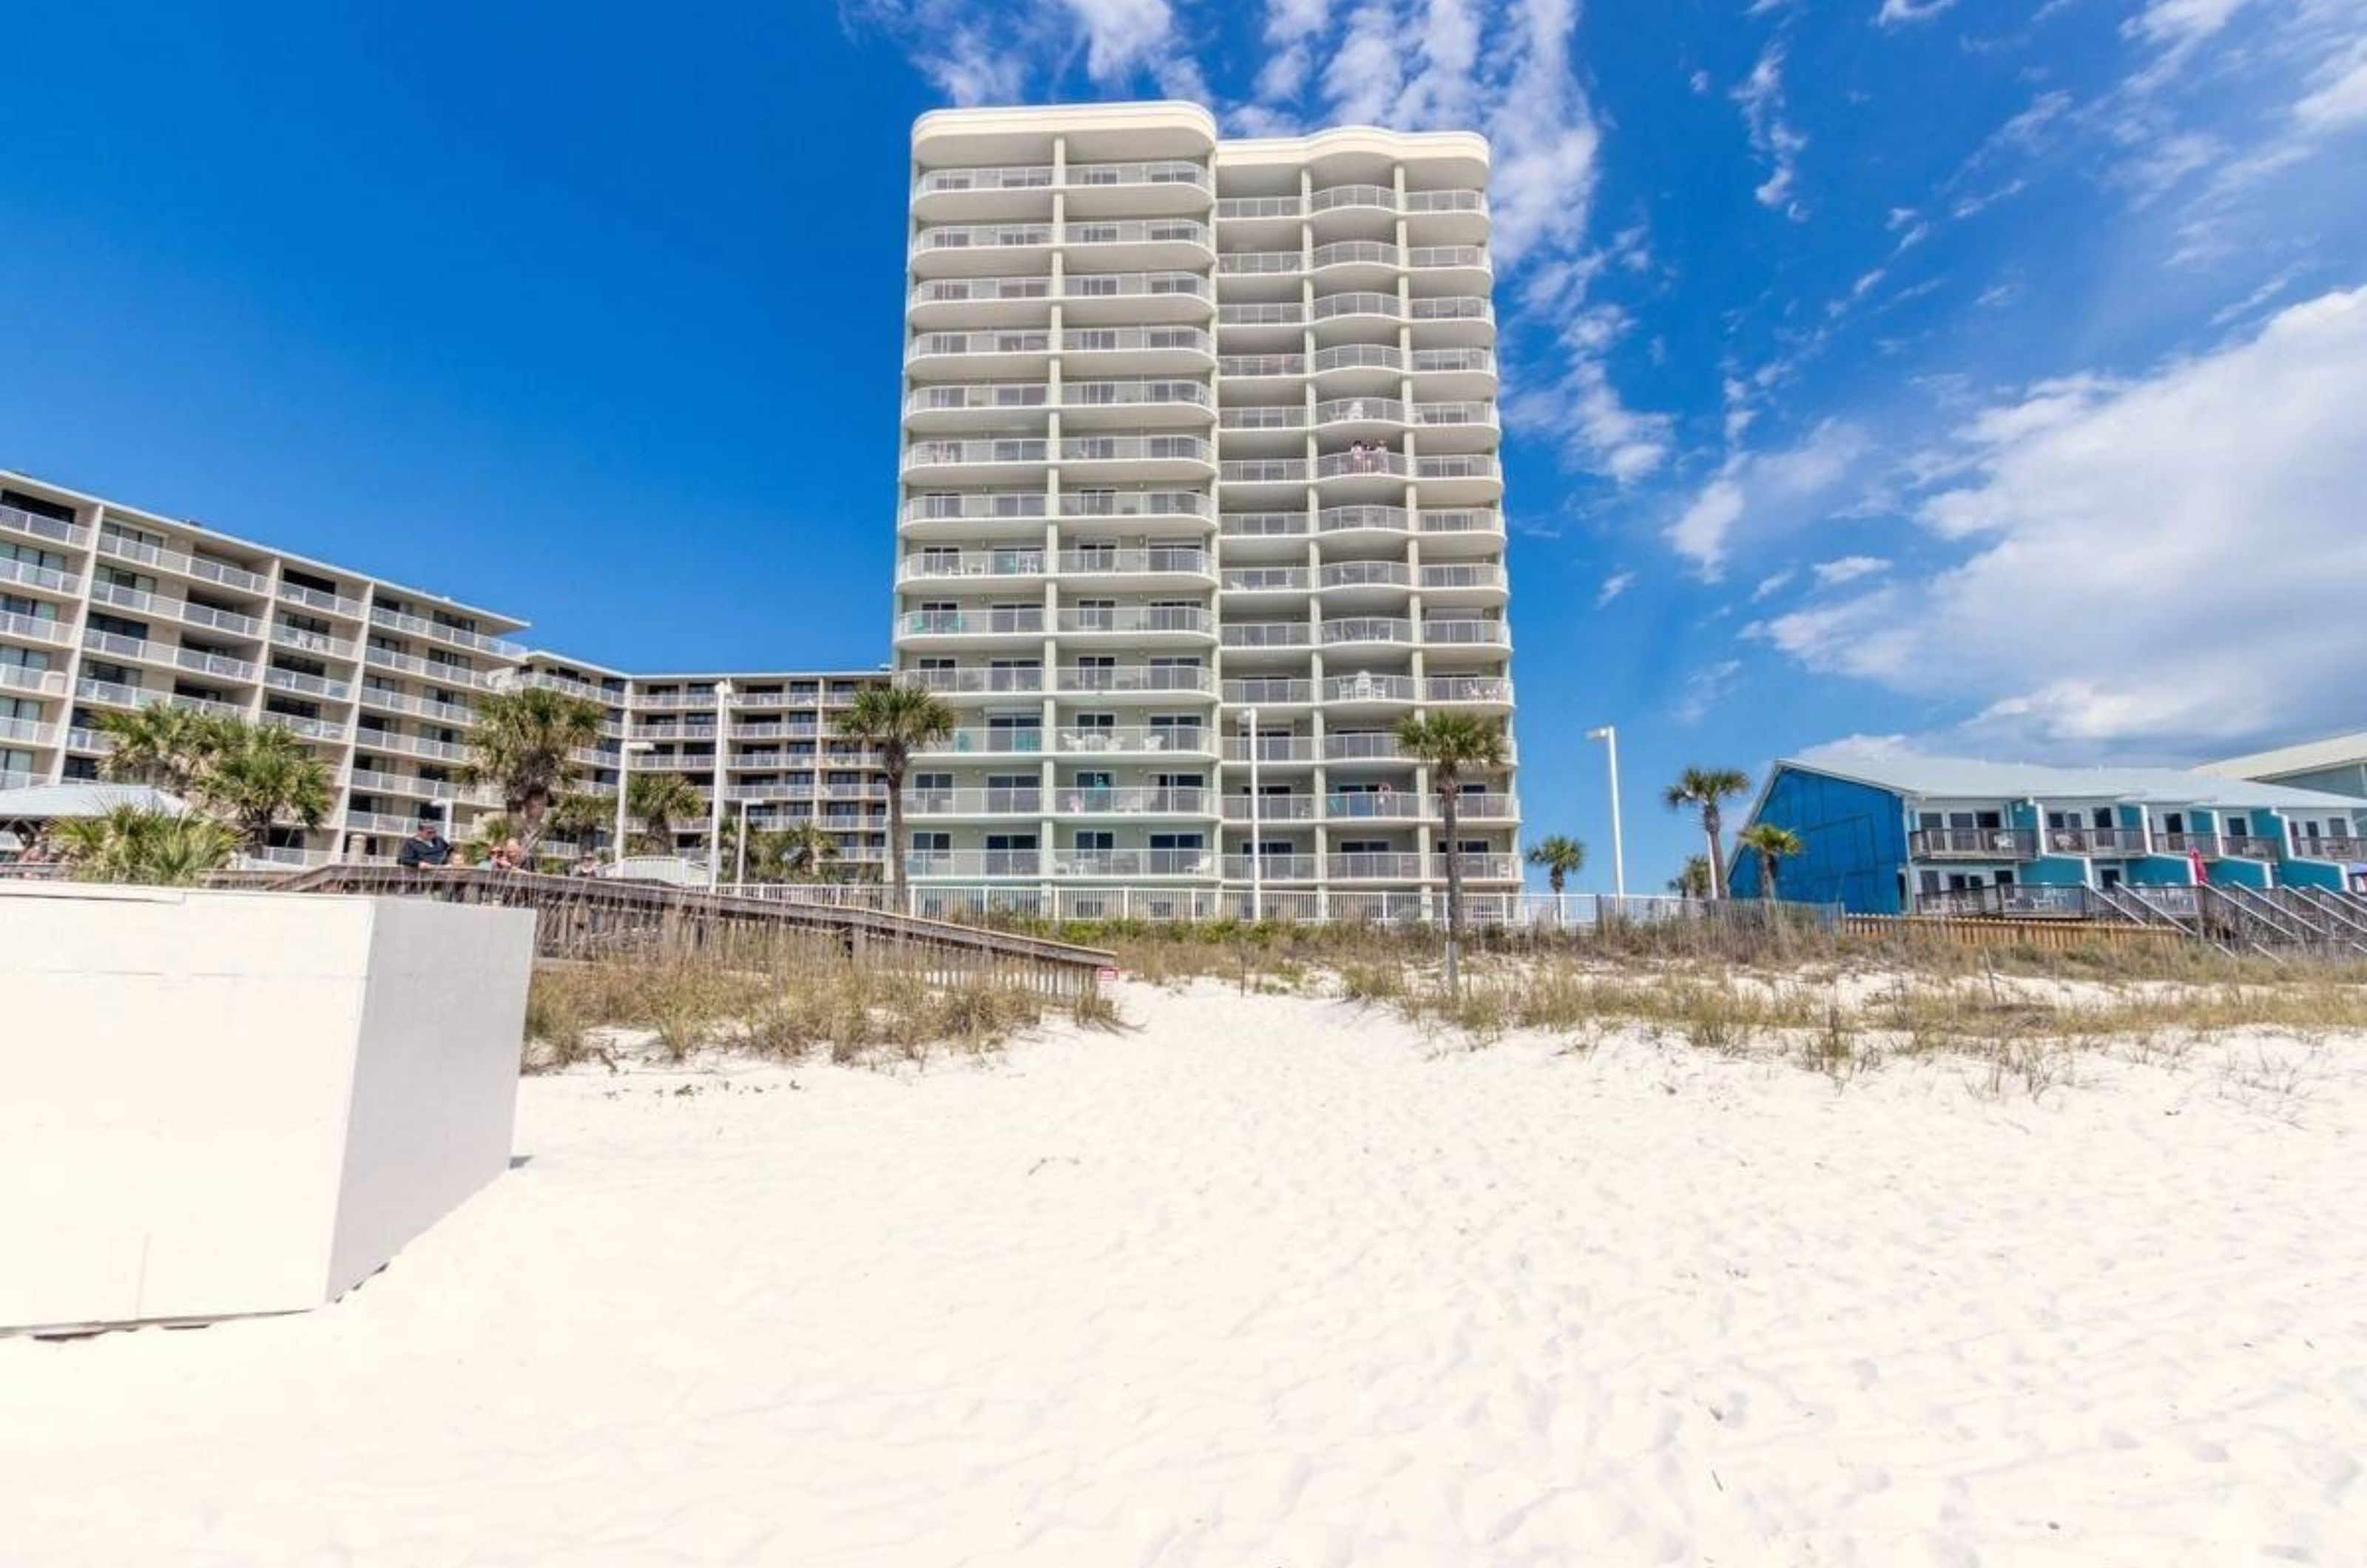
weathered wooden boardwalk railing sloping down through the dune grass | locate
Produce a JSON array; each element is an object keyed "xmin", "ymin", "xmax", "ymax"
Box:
[{"xmin": 249, "ymin": 865, "xmax": 1117, "ymax": 999}]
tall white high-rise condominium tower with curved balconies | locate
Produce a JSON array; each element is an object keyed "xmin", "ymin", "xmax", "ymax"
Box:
[{"xmin": 895, "ymin": 104, "xmax": 1519, "ymax": 910}]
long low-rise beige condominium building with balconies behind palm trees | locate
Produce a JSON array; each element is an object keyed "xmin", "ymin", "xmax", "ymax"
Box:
[{"xmin": 0, "ymin": 471, "xmax": 888, "ymax": 869}]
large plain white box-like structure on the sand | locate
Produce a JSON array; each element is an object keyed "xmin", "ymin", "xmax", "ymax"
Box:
[{"xmin": 0, "ymin": 884, "xmax": 533, "ymax": 1329}]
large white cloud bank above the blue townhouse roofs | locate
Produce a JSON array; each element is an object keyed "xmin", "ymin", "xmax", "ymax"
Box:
[{"xmin": 1763, "ymin": 289, "xmax": 2367, "ymax": 753}]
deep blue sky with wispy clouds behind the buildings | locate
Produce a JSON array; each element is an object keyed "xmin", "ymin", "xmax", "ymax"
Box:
[{"xmin": 0, "ymin": 0, "xmax": 2367, "ymax": 888}]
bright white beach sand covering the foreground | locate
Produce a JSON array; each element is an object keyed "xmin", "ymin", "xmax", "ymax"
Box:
[{"xmin": 13, "ymin": 987, "xmax": 2367, "ymax": 1568}]
